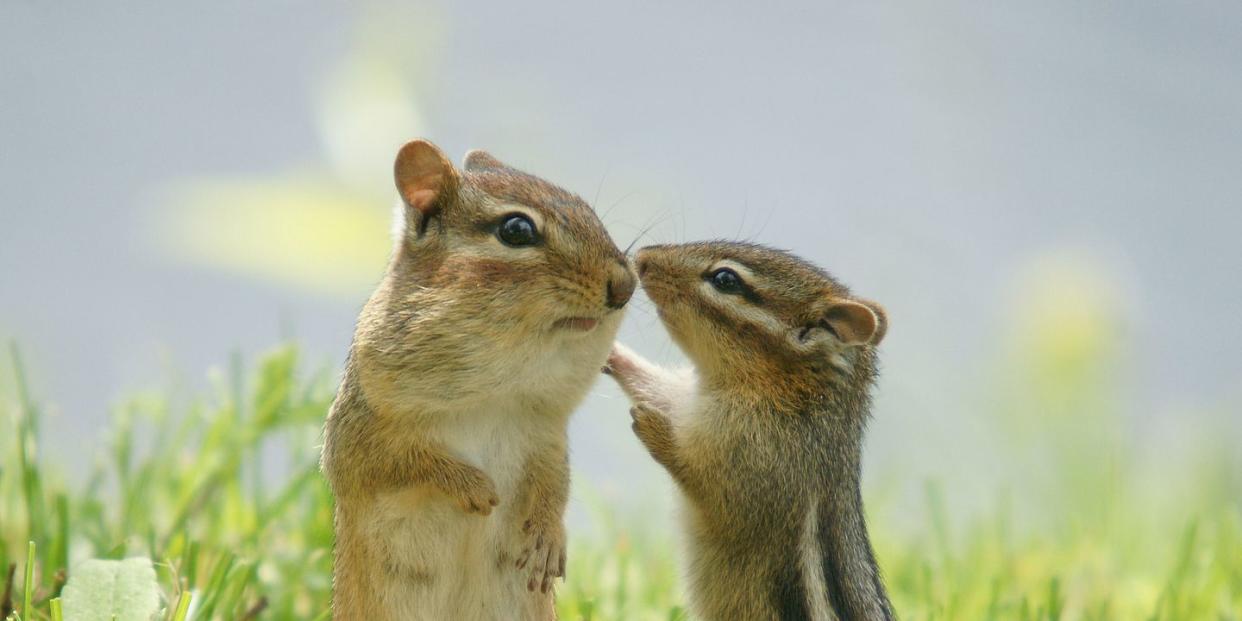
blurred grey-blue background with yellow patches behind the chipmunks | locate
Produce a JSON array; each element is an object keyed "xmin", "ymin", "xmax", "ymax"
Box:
[{"xmin": 0, "ymin": 1, "xmax": 1242, "ymax": 539}]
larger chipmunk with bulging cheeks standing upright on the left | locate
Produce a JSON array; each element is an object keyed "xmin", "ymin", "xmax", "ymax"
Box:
[{"xmin": 323, "ymin": 140, "xmax": 636, "ymax": 621}]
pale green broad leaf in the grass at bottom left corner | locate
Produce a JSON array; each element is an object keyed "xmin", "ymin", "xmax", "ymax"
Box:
[{"xmin": 61, "ymin": 558, "xmax": 159, "ymax": 621}]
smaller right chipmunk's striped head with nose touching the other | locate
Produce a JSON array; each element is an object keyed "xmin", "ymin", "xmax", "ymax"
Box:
[{"xmin": 636, "ymin": 242, "xmax": 887, "ymax": 388}]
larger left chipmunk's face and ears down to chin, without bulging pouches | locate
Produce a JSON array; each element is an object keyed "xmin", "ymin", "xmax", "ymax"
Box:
[{"xmin": 395, "ymin": 140, "xmax": 635, "ymax": 333}]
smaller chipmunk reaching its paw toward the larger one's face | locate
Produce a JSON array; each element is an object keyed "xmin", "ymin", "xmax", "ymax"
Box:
[{"xmin": 604, "ymin": 242, "xmax": 894, "ymax": 621}]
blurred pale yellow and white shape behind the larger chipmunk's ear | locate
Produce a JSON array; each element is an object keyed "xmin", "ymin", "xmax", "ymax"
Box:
[{"xmin": 146, "ymin": 5, "xmax": 442, "ymax": 296}]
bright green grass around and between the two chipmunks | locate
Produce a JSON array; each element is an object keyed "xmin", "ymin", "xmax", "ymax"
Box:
[{"xmin": 0, "ymin": 347, "xmax": 1242, "ymax": 621}]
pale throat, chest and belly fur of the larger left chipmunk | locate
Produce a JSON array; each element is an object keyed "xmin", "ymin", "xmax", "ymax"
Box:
[{"xmin": 364, "ymin": 327, "xmax": 621, "ymax": 621}]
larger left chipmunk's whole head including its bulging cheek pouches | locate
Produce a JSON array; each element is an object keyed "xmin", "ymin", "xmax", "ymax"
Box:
[{"xmin": 363, "ymin": 140, "xmax": 636, "ymax": 401}]
